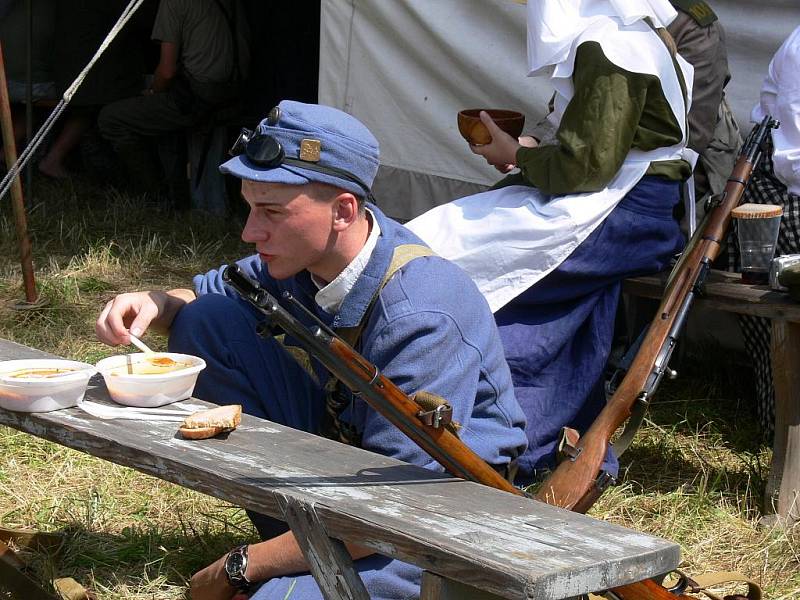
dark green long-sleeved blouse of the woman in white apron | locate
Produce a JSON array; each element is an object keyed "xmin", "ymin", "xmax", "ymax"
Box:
[{"xmin": 494, "ymin": 42, "xmax": 691, "ymax": 195}]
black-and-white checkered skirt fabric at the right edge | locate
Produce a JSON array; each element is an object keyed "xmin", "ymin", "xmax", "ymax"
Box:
[{"xmin": 728, "ymin": 135, "xmax": 800, "ymax": 437}]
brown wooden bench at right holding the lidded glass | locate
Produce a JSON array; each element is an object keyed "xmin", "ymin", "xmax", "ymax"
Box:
[{"xmin": 622, "ymin": 270, "xmax": 800, "ymax": 523}]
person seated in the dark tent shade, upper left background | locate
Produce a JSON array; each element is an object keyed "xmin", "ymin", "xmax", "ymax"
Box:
[{"xmin": 99, "ymin": 0, "xmax": 249, "ymax": 208}]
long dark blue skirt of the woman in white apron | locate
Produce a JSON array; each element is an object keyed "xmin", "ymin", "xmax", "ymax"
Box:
[{"xmin": 495, "ymin": 176, "xmax": 685, "ymax": 484}]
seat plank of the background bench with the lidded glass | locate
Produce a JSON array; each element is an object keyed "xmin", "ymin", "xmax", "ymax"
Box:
[{"xmin": 622, "ymin": 270, "xmax": 800, "ymax": 322}]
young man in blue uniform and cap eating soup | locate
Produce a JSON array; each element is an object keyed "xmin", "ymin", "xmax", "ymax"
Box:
[{"xmin": 97, "ymin": 101, "xmax": 526, "ymax": 599}]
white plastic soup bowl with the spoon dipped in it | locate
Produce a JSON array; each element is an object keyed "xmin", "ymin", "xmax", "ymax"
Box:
[{"xmin": 96, "ymin": 352, "xmax": 206, "ymax": 408}]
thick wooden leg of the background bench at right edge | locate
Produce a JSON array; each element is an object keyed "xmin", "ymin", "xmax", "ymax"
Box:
[{"xmin": 765, "ymin": 319, "xmax": 800, "ymax": 524}]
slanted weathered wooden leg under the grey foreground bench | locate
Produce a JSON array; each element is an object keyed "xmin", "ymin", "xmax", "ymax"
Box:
[{"xmin": 284, "ymin": 499, "xmax": 369, "ymax": 600}]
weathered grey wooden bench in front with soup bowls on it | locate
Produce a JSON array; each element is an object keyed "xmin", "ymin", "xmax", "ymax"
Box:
[{"xmin": 0, "ymin": 340, "xmax": 680, "ymax": 600}]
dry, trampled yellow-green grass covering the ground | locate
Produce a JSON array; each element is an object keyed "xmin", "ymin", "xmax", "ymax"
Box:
[{"xmin": 0, "ymin": 180, "xmax": 800, "ymax": 600}]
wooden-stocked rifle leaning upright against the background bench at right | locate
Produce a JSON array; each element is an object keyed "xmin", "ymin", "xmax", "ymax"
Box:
[{"xmin": 536, "ymin": 116, "xmax": 779, "ymax": 512}]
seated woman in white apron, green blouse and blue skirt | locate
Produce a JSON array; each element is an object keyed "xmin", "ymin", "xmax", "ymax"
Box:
[{"xmin": 408, "ymin": 0, "xmax": 692, "ymax": 483}]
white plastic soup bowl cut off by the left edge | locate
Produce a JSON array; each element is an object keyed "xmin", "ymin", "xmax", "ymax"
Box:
[{"xmin": 0, "ymin": 358, "xmax": 96, "ymax": 412}]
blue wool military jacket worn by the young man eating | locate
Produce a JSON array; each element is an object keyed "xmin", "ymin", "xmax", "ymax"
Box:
[{"xmin": 194, "ymin": 205, "xmax": 527, "ymax": 469}]
